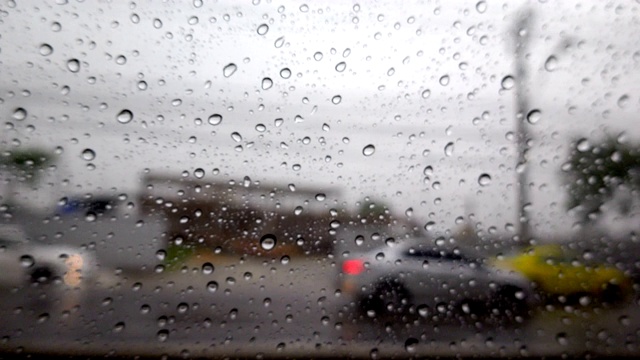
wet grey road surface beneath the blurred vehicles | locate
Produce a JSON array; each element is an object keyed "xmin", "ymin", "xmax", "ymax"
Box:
[{"xmin": 0, "ymin": 260, "xmax": 640, "ymax": 358}]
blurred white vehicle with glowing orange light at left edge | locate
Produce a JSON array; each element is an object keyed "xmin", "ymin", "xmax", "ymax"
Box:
[{"xmin": 0, "ymin": 225, "xmax": 96, "ymax": 290}]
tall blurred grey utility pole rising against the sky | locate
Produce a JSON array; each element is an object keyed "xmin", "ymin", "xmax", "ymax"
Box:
[{"xmin": 511, "ymin": 8, "xmax": 533, "ymax": 244}]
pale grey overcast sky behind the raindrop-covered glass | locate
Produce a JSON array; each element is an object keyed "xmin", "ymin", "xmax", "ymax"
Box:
[{"xmin": 0, "ymin": 0, "xmax": 640, "ymax": 239}]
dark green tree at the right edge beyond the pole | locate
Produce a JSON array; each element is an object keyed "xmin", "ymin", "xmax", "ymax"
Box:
[{"xmin": 563, "ymin": 136, "xmax": 640, "ymax": 221}]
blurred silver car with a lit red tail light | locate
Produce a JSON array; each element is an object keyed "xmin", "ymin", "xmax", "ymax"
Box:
[{"xmin": 339, "ymin": 241, "xmax": 536, "ymax": 319}]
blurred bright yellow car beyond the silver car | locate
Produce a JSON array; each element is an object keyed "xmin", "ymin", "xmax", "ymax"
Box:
[{"xmin": 496, "ymin": 244, "xmax": 632, "ymax": 302}]
